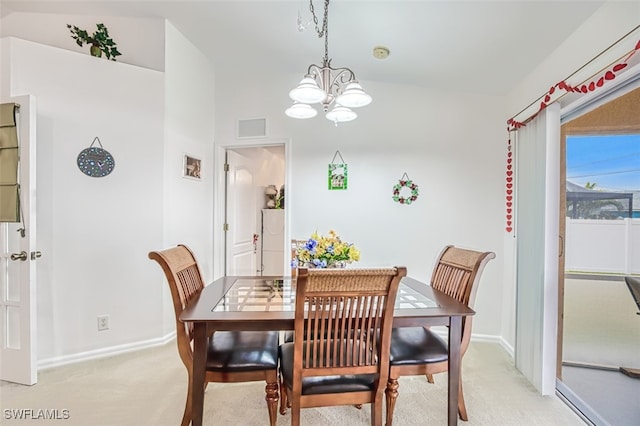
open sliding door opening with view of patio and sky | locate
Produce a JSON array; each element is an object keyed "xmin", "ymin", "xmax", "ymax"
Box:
[{"xmin": 556, "ymin": 88, "xmax": 640, "ymax": 425}]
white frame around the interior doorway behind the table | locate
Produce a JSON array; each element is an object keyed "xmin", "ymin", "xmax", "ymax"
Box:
[{"xmin": 213, "ymin": 139, "xmax": 294, "ymax": 279}]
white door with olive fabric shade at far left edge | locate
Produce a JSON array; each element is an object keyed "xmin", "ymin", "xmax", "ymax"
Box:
[{"xmin": 0, "ymin": 96, "xmax": 40, "ymax": 385}]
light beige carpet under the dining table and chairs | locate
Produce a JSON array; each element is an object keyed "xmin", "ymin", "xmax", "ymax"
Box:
[{"xmin": 0, "ymin": 342, "xmax": 585, "ymax": 426}]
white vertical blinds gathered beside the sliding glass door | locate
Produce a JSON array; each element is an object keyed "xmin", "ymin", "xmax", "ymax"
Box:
[{"xmin": 515, "ymin": 103, "xmax": 560, "ymax": 395}]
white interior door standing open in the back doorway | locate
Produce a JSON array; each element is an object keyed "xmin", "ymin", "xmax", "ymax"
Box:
[{"xmin": 226, "ymin": 150, "xmax": 258, "ymax": 275}]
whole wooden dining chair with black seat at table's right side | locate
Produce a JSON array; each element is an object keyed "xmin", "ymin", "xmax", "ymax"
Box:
[{"xmin": 385, "ymin": 246, "xmax": 496, "ymax": 426}]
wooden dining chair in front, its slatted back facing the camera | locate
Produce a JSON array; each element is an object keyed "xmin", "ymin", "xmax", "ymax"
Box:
[{"xmin": 280, "ymin": 267, "xmax": 407, "ymax": 426}]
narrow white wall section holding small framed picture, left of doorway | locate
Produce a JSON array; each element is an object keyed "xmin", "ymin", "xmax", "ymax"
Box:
[{"xmin": 160, "ymin": 22, "xmax": 215, "ymax": 334}]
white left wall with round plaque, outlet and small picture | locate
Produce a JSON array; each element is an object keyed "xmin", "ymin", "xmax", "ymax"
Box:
[{"xmin": 2, "ymin": 14, "xmax": 214, "ymax": 366}]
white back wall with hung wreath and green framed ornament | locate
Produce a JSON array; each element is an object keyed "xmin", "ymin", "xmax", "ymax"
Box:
[{"xmin": 216, "ymin": 64, "xmax": 505, "ymax": 338}]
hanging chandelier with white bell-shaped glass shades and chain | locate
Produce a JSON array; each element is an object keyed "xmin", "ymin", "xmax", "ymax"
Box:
[{"xmin": 285, "ymin": 0, "xmax": 371, "ymax": 126}]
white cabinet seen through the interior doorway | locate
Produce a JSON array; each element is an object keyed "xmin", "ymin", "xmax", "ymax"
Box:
[{"xmin": 261, "ymin": 209, "xmax": 284, "ymax": 275}]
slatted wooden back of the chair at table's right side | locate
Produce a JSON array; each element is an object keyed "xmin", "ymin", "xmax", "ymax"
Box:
[{"xmin": 431, "ymin": 245, "xmax": 496, "ymax": 354}]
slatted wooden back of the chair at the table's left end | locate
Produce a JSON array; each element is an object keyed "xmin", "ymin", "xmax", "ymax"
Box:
[{"xmin": 149, "ymin": 244, "xmax": 204, "ymax": 369}]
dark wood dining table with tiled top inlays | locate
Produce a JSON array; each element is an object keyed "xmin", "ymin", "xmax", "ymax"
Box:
[{"xmin": 180, "ymin": 276, "xmax": 475, "ymax": 426}]
